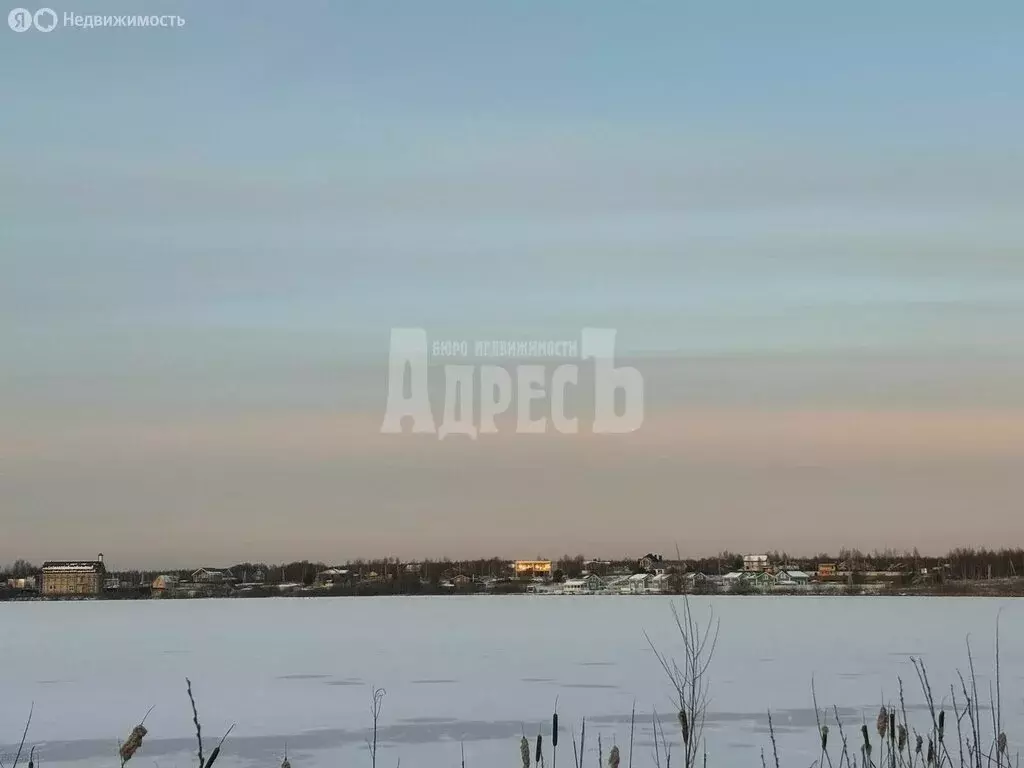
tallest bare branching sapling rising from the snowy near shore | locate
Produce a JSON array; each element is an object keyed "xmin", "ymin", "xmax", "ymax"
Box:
[{"xmin": 644, "ymin": 598, "xmax": 720, "ymax": 768}]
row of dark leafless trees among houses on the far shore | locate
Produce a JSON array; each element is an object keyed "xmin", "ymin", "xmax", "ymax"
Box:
[{"xmin": 0, "ymin": 547, "xmax": 1024, "ymax": 591}]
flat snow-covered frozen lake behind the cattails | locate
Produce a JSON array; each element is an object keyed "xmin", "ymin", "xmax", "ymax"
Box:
[{"xmin": 0, "ymin": 596, "xmax": 1024, "ymax": 768}]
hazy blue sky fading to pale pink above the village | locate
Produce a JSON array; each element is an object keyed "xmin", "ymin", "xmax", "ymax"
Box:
[{"xmin": 0, "ymin": 0, "xmax": 1024, "ymax": 567}]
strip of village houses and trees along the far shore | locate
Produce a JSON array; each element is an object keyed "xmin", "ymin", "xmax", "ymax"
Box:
[{"xmin": 0, "ymin": 549, "xmax": 1024, "ymax": 600}]
